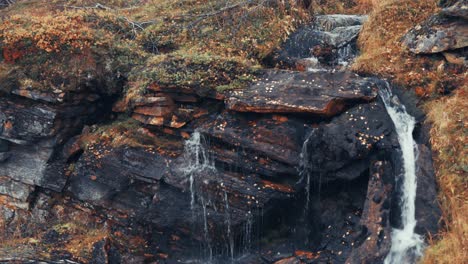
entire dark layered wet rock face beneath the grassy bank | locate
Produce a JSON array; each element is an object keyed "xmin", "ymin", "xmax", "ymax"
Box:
[{"xmin": 0, "ymin": 16, "xmax": 438, "ymax": 263}]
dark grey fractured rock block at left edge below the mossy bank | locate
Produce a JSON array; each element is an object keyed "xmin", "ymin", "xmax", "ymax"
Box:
[{"xmin": 0, "ymin": 93, "xmax": 113, "ymax": 192}]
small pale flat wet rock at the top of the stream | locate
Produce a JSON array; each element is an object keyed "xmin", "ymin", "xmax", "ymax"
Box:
[{"xmin": 315, "ymin": 15, "xmax": 367, "ymax": 31}]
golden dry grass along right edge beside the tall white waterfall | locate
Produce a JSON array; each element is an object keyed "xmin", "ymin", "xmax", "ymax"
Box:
[{"xmin": 422, "ymin": 83, "xmax": 468, "ymax": 264}]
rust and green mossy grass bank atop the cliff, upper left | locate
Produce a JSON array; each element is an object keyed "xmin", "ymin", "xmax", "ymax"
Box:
[{"xmin": 0, "ymin": 0, "xmax": 310, "ymax": 102}]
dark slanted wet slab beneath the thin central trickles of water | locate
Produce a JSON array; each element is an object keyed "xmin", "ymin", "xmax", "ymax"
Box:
[{"xmin": 68, "ymin": 135, "xmax": 294, "ymax": 255}]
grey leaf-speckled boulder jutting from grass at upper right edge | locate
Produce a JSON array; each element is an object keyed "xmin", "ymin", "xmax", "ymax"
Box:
[{"xmin": 403, "ymin": 14, "xmax": 468, "ymax": 54}]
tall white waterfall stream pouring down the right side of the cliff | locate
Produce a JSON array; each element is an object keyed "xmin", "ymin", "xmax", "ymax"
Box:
[{"xmin": 379, "ymin": 83, "xmax": 424, "ymax": 264}]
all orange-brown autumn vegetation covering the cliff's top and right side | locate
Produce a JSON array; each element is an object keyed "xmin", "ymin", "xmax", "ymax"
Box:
[{"xmin": 0, "ymin": 0, "xmax": 468, "ymax": 263}]
